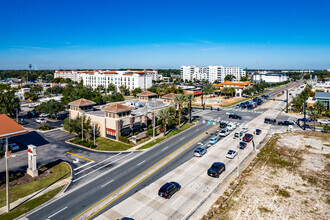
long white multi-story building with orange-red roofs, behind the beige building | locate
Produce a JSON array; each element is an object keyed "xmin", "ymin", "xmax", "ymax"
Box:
[{"xmin": 54, "ymin": 69, "xmax": 161, "ymax": 90}]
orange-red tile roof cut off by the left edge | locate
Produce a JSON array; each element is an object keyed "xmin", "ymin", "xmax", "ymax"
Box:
[{"xmin": 0, "ymin": 114, "xmax": 28, "ymax": 138}]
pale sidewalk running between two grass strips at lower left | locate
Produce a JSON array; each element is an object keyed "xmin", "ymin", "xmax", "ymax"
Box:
[{"xmin": 0, "ymin": 177, "xmax": 71, "ymax": 215}]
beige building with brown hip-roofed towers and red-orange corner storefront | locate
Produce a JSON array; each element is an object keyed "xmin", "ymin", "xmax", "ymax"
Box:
[{"xmin": 69, "ymin": 99, "xmax": 154, "ymax": 141}]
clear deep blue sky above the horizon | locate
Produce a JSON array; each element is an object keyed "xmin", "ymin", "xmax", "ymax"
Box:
[{"xmin": 0, "ymin": 0, "xmax": 330, "ymax": 69}]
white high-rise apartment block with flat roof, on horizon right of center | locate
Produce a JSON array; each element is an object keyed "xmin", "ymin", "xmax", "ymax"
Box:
[{"xmin": 181, "ymin": 66, "xmax": 246, "ymax": 82}]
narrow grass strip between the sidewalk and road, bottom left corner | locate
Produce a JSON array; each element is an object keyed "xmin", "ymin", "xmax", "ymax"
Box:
[{"xmin": 0, "ymin": 186, "xmax": 64, "ymax": 220}]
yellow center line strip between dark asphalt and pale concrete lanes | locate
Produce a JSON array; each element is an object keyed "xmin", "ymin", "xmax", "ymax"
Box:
[{"xmin": 72, "ymin": 126, "xmax": 216, "ymax": 220}]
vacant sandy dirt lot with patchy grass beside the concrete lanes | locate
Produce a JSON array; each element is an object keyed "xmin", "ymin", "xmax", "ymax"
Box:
[{"xmin": 203, "ymin": 132, "xmax": 330, "ymax": 219}]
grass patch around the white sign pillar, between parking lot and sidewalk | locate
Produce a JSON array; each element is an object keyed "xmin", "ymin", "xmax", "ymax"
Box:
[{"xmin": 0, "ymin": 162, "xmax": 71, "ymax": 207}]
